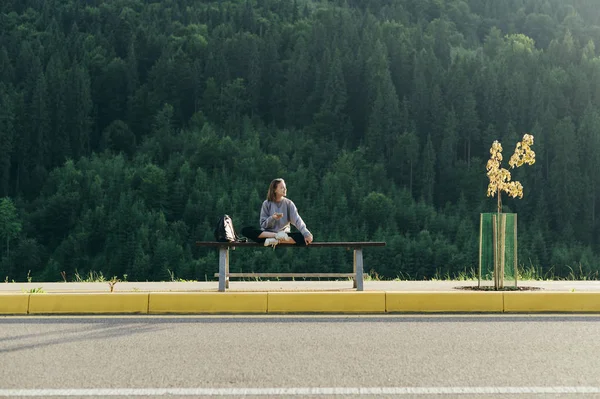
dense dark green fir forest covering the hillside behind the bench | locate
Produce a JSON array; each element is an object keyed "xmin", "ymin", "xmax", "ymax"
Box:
[{"xmin": 0, "ymin": 0, "xmax": 600, "ymax": 281}]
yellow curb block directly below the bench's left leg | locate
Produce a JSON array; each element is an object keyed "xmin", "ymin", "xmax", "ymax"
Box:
[{"xmin": 148, "ymin": 292, "xmax": 267, "ymax": 314}]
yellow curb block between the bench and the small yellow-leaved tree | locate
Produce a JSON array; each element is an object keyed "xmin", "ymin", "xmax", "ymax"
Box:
[{"xmin": 386, "ymin": 291, "xmax": 503, "ymax": 312}]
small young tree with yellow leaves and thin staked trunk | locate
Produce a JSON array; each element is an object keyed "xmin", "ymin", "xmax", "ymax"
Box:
[{"xmin": 486, "ymin": 134, "xmax": 535, "ymax": 289}]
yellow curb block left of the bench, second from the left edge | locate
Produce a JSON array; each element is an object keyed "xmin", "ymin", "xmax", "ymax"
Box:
[{"xmin": 29, "ymin": 292, "xmax": 148, "ymax": 314}]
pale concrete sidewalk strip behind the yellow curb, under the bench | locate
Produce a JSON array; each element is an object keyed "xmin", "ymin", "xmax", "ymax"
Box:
[{"xmin": 0, "ymin": 280, "xmax": 600, "ymax": 293}]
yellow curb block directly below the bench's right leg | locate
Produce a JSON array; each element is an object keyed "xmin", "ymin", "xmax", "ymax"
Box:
[{"xmin": 268, "ymin": 292, "xmax": 385, "ymax": 313}]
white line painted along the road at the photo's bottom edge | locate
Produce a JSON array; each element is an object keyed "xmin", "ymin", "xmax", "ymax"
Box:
[{"xmin": 0, "ymin": 386, "xmax": 600, "ymax": 397}]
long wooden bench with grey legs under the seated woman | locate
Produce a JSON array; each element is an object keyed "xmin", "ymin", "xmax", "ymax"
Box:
[{"xmin": 196, "ymin": 241, "xmax": 385, "ymax": 292}]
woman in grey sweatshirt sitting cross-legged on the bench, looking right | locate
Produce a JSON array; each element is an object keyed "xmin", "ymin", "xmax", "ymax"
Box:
[{"xmin": 242, "ymin": 179, "xmax": 313, "ymax": 247}]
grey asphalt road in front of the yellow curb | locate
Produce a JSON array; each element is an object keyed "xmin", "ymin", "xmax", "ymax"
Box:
[{"xmin": 0, "ymin": 315, "xmax": 600, "ymax": 398}]
